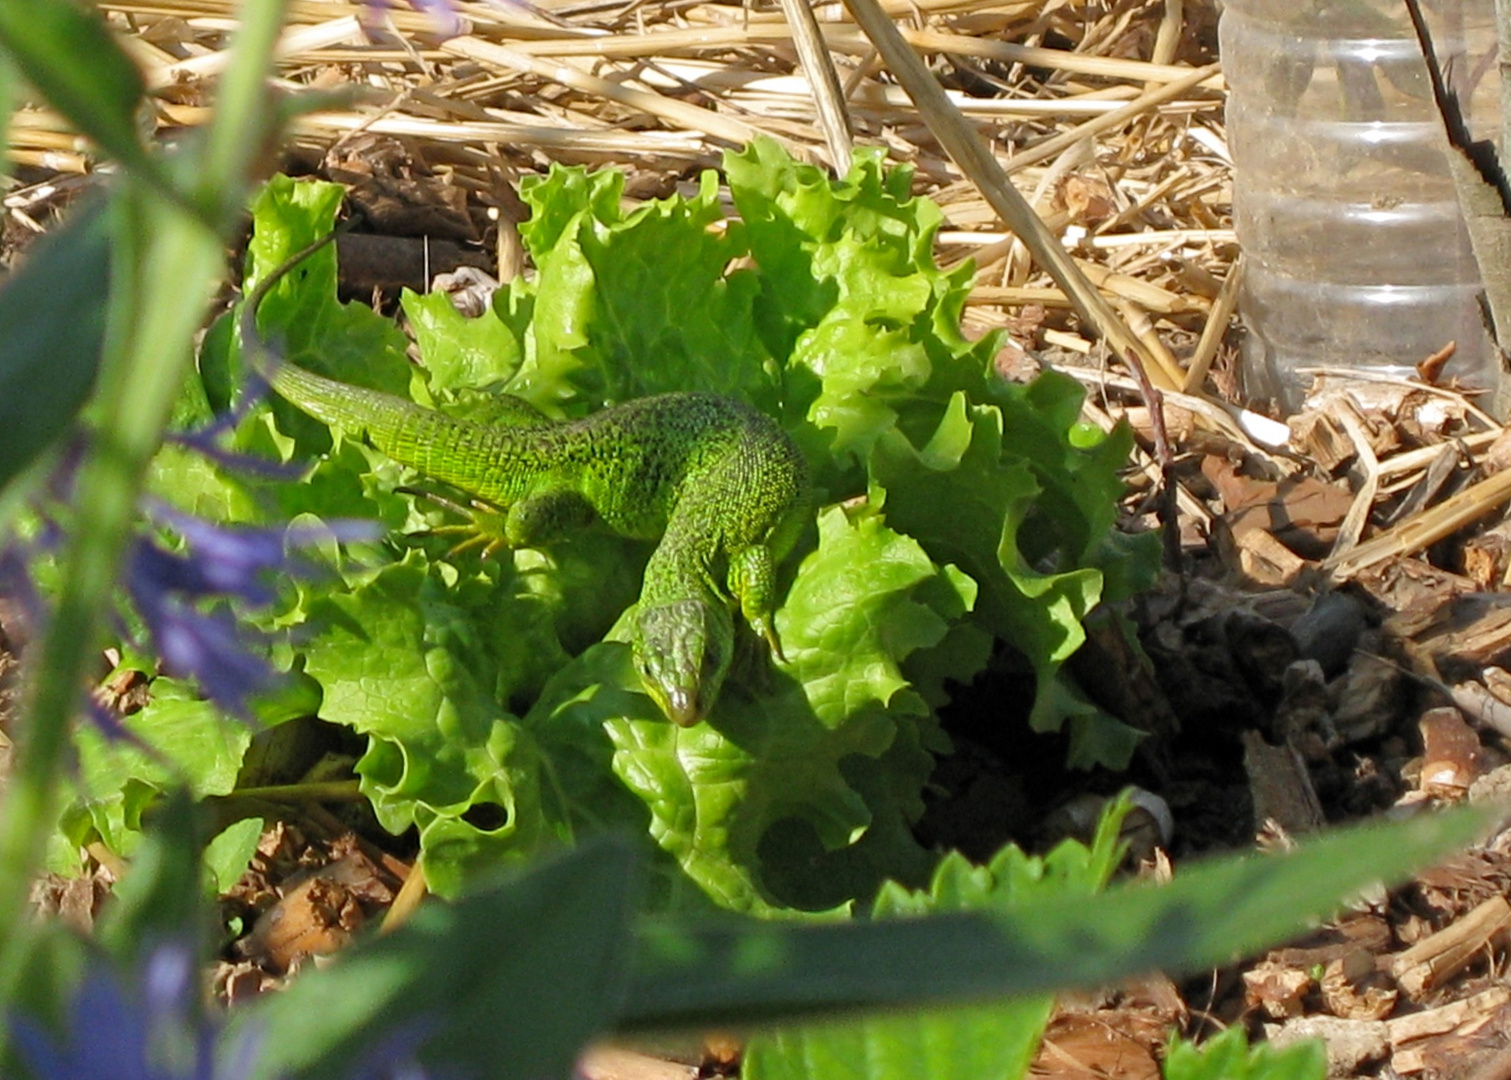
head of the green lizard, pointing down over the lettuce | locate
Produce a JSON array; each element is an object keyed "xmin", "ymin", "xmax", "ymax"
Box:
[{"xmin": 633, "ymin": 600, "xmax": 734, "ymax": 728}]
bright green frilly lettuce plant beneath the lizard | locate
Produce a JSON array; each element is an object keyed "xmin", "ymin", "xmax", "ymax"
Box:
[{"xmin": 61, "ymin": 143, "xmax": 1154, "ymax": 912}]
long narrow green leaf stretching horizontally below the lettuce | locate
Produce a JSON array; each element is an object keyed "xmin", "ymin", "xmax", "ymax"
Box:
[{"xmin": 620, "ymin": 811, "xmax": 1485, "ymax": 1029}]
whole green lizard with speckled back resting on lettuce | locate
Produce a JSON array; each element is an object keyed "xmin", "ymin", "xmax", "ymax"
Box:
[{"xmin": 240, "ymin": 234, "xmax": 810, "ymax": 727}]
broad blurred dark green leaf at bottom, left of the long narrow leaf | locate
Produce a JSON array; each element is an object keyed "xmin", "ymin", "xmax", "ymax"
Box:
[{"xmin": 237, "ymin": 841, "xmax": 635, "ymax": 1080}]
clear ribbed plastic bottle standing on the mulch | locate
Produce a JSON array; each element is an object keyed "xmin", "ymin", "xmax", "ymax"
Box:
[{"xmin": 1218, "ymin": 0, "xmax": 1499, "ymax": 409}]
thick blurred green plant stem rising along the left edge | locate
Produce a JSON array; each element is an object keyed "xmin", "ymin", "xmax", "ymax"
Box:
[{"xmin": 0, "ymin": 0, "xmax": 286, "ymax": 1015}]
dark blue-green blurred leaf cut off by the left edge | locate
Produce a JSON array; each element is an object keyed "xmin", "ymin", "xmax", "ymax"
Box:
[{"xmin": 0, "ymin": 197, "xmax": 110, "ymax": 486}]
